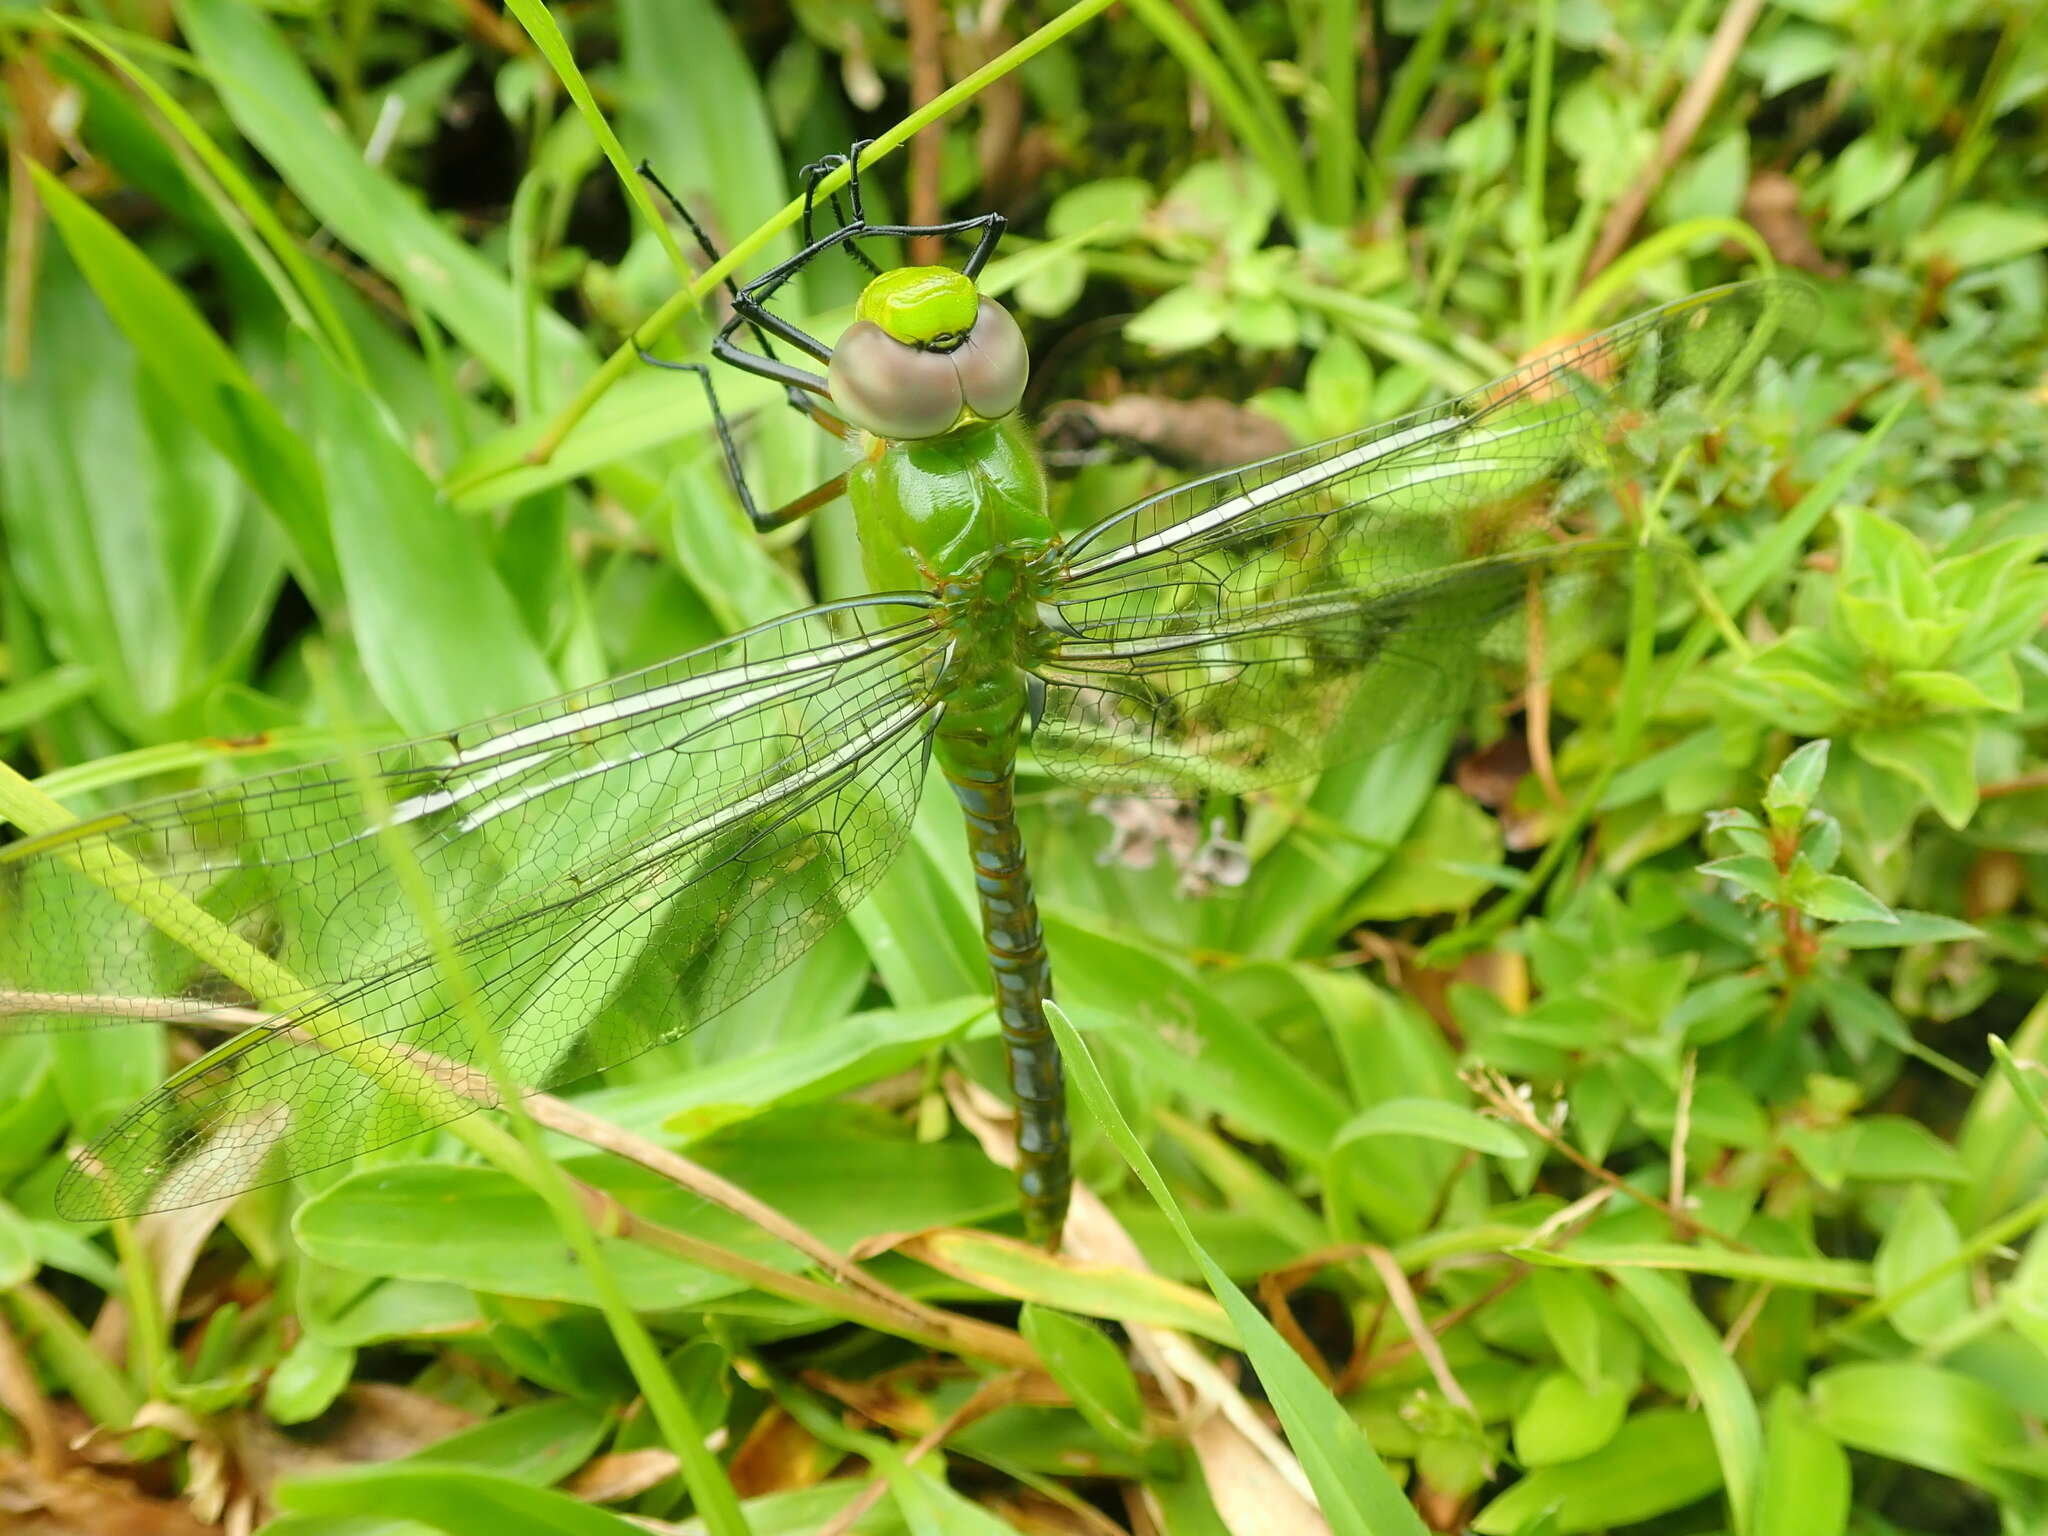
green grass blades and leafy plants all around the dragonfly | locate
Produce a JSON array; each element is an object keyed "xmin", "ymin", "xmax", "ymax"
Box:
[{"xmin": 0, "ymin": 0, "xmax": 2048, "ymax": 1536}]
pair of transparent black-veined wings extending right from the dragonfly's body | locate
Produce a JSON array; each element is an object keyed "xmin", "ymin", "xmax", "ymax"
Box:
[{"xmin": 1032, "ymin": 283, "xmax": 1812, "ymax": 793}]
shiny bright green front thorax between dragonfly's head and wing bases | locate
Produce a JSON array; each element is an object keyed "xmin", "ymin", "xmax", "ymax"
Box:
[{"xmin": 846, "ymin": 414, "xmax": 1053, "ymax": 592}]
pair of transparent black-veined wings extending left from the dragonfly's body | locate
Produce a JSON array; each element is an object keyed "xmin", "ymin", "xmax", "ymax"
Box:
[{"xmin": 0, "ymin": 596, "xmax": 944, "ymax": 1217}]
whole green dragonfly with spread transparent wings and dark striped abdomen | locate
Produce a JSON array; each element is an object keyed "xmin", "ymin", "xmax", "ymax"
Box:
[{"xmin": 0, "ymin": 145, "xmax": 1800, "ymax": 1245}]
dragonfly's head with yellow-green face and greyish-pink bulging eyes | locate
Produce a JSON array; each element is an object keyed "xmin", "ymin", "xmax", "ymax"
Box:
[{"xmin": 827, "ymin": 266, "xmax": 1030, "ymax": 440}]
